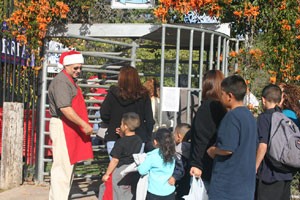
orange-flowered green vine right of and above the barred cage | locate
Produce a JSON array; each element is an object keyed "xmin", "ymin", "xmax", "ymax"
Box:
[{"xmin": 154, "ymin": 0, "xmax": 300, "ymax": 82}]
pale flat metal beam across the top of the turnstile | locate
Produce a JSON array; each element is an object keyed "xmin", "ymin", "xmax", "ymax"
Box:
[{"xmin": 47, "ymin": 23, "xmax": 230, "ymax": 41}]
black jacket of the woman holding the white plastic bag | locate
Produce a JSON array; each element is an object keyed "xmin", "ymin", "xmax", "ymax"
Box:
[{"xmin": 190, "ymin": 100, "xmax": 226, "ymax": 181}]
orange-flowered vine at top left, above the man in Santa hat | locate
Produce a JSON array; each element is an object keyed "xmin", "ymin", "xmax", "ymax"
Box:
[{"xmin": 5, "ymin": 0, "xmax": 69, "ymax": 69}]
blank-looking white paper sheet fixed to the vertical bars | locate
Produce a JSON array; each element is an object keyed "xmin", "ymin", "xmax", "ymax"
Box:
[{"xmin": 161, "ymin": 87, "xmax": 180, "ymax": 112}]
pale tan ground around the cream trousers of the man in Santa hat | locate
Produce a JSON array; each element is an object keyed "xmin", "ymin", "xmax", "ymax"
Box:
[{"xmin": 0, "ymin": 181, "xmax": 100, "ymax": 200}]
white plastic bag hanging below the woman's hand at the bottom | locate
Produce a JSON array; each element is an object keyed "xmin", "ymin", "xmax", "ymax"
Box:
[{"xmin": 182, "ymin": 176, "xmax": 208, "ymax": 200}]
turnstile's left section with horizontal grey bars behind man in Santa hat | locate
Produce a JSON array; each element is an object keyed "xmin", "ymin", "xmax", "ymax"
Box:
[{"xmin": 36, "ymin": 35, "xmax": 138, "ymax": 182}]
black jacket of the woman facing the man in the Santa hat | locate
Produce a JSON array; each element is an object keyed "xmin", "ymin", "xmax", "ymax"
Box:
[{"xmin": 100, "ymin": 86, "xmax": 155, "ymax": 142}]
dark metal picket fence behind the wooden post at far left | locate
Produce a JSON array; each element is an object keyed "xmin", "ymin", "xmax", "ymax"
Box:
[{"xmin": 0, "ymin": 36, "xmax": 39, "ymax": 169}]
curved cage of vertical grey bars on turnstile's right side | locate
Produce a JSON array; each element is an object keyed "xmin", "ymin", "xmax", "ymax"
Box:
[{"xmin": 151, "ymin": 24, "xmax": 233, "ymax": 127}]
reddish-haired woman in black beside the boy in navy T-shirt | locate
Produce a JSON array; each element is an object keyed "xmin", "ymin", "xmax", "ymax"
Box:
[{"xmin": 190, "ymin": 70, "xmax": 226, "ymax": 190}]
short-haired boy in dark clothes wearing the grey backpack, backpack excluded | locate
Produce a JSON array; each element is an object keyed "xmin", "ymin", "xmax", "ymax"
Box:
[{"xmin": 255, "ymin": 84, "xmax": 293, "ymax": 200}]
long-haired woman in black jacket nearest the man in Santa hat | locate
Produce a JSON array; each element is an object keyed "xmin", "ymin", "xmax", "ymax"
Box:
[{"xmin": 100, "ymin": 66, "xmax": 155, "ymax": 154}]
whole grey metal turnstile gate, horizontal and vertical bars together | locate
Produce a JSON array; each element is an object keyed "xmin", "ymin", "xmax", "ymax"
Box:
[{"xmin": 36, "ymin": 24, "xmax": 237, "ymax": 189}]
